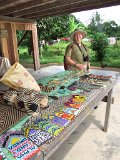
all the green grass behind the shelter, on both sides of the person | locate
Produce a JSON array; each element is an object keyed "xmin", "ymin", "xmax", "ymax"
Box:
[{"xmin": 19, "ymin": 41, "xmax": 120, "ymax": 68}]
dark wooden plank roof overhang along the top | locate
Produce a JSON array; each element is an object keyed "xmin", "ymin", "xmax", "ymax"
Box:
[{"xmin": 0, "ymin": 0, "xmax": 120, "ymax": 19}]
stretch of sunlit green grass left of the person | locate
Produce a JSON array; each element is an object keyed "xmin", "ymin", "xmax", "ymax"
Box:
[{"xmin": 20, "ymin": 41, "xmax": 69, "ymax": 64}]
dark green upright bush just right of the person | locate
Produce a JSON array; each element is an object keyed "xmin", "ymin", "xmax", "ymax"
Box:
[{"xmin": 91, "ymin": 32, "xmax": 108, "ymax": 65}]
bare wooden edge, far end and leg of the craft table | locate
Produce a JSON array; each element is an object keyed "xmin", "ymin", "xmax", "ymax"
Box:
[{"xmin": 36, "ymin": 70, "xmax": 119, "ymax": 160}]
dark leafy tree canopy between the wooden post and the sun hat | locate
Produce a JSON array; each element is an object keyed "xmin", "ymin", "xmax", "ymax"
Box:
[{"xmin": 37, "ymin": 15, "xmax": 73, "ymax": 41}]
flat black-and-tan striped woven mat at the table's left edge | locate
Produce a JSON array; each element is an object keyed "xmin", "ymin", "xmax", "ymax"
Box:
[{"xmin": 0, "ymin": 104, "xmax": 26, "ymax": 134}]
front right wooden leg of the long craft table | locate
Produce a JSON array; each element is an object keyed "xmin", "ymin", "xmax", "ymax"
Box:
[{"xmin": 104, "ymin": 89, "xmax": 112, "ymax": 132}]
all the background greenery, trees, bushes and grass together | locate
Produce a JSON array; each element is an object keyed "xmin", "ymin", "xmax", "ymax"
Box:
[{"xmin": 17, "ymin": 12, "xmax": 120, "ymax": 67}]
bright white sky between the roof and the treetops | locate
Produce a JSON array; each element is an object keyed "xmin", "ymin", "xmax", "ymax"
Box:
[{"xmin": 72, "ymin": 5, "xmax": 120, "ymax": 25}]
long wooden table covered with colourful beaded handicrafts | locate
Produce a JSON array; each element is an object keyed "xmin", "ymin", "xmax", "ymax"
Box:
[{"xmin": 0, "ymin": 71, "xmax": 118, "ymax": 160}]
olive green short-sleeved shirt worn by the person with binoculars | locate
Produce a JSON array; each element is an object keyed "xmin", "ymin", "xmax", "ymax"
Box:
[{"xmin": 65, "ymin": 43, "xmax": 88, "ymax": 71}]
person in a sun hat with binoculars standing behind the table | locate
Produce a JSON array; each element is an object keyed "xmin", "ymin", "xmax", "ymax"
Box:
[{"xmin": 64, "ymin": 28, "xmax": 90, "ymax": 71}]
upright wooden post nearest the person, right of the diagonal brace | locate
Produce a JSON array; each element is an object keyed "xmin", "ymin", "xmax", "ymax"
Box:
[{"xmin": 32, "ymin": 24, "xmax": 40, "ymax": 70}]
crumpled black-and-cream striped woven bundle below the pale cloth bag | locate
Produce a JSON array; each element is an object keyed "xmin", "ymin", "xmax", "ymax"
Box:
[{"xmin": 3, "ymin": 88, "xmax": 48, "ymax": 114}]
